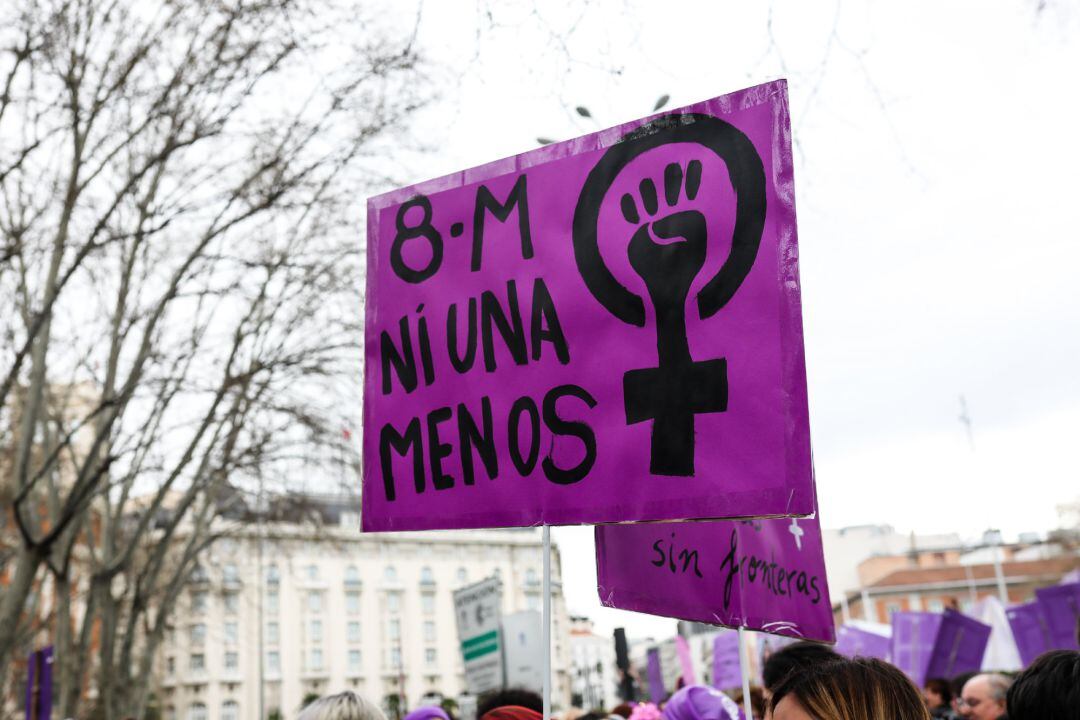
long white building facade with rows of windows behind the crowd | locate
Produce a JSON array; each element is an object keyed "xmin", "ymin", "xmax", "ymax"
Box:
[{"xmin": 158, "ymin": 500, "xmax": 570, "ymax": 720}]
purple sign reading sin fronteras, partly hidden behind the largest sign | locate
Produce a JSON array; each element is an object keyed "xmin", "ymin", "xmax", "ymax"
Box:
[{"xmin": 596, "ymin": 507, "xmax": 835, "ymax": 642}]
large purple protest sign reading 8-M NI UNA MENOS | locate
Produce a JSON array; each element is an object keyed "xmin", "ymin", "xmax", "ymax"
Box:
[{"xmin": 363, "ymin": 81, "xmax": 813, "ymax": 531}]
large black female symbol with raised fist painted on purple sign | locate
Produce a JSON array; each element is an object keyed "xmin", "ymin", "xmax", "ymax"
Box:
[{"xmin": 573, "ymin": 113, "xmax": 766, "ymax": 476}]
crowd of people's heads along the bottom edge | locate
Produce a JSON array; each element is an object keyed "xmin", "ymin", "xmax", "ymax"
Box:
[{"xmin": 298, "ymin": 642, "xmax": 1080, "ymax": 720}]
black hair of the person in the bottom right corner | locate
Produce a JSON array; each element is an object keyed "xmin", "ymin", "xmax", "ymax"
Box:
[{"xmin": 1005, "ymin": 650, "xmax": 1080, "ymax": 720}]
